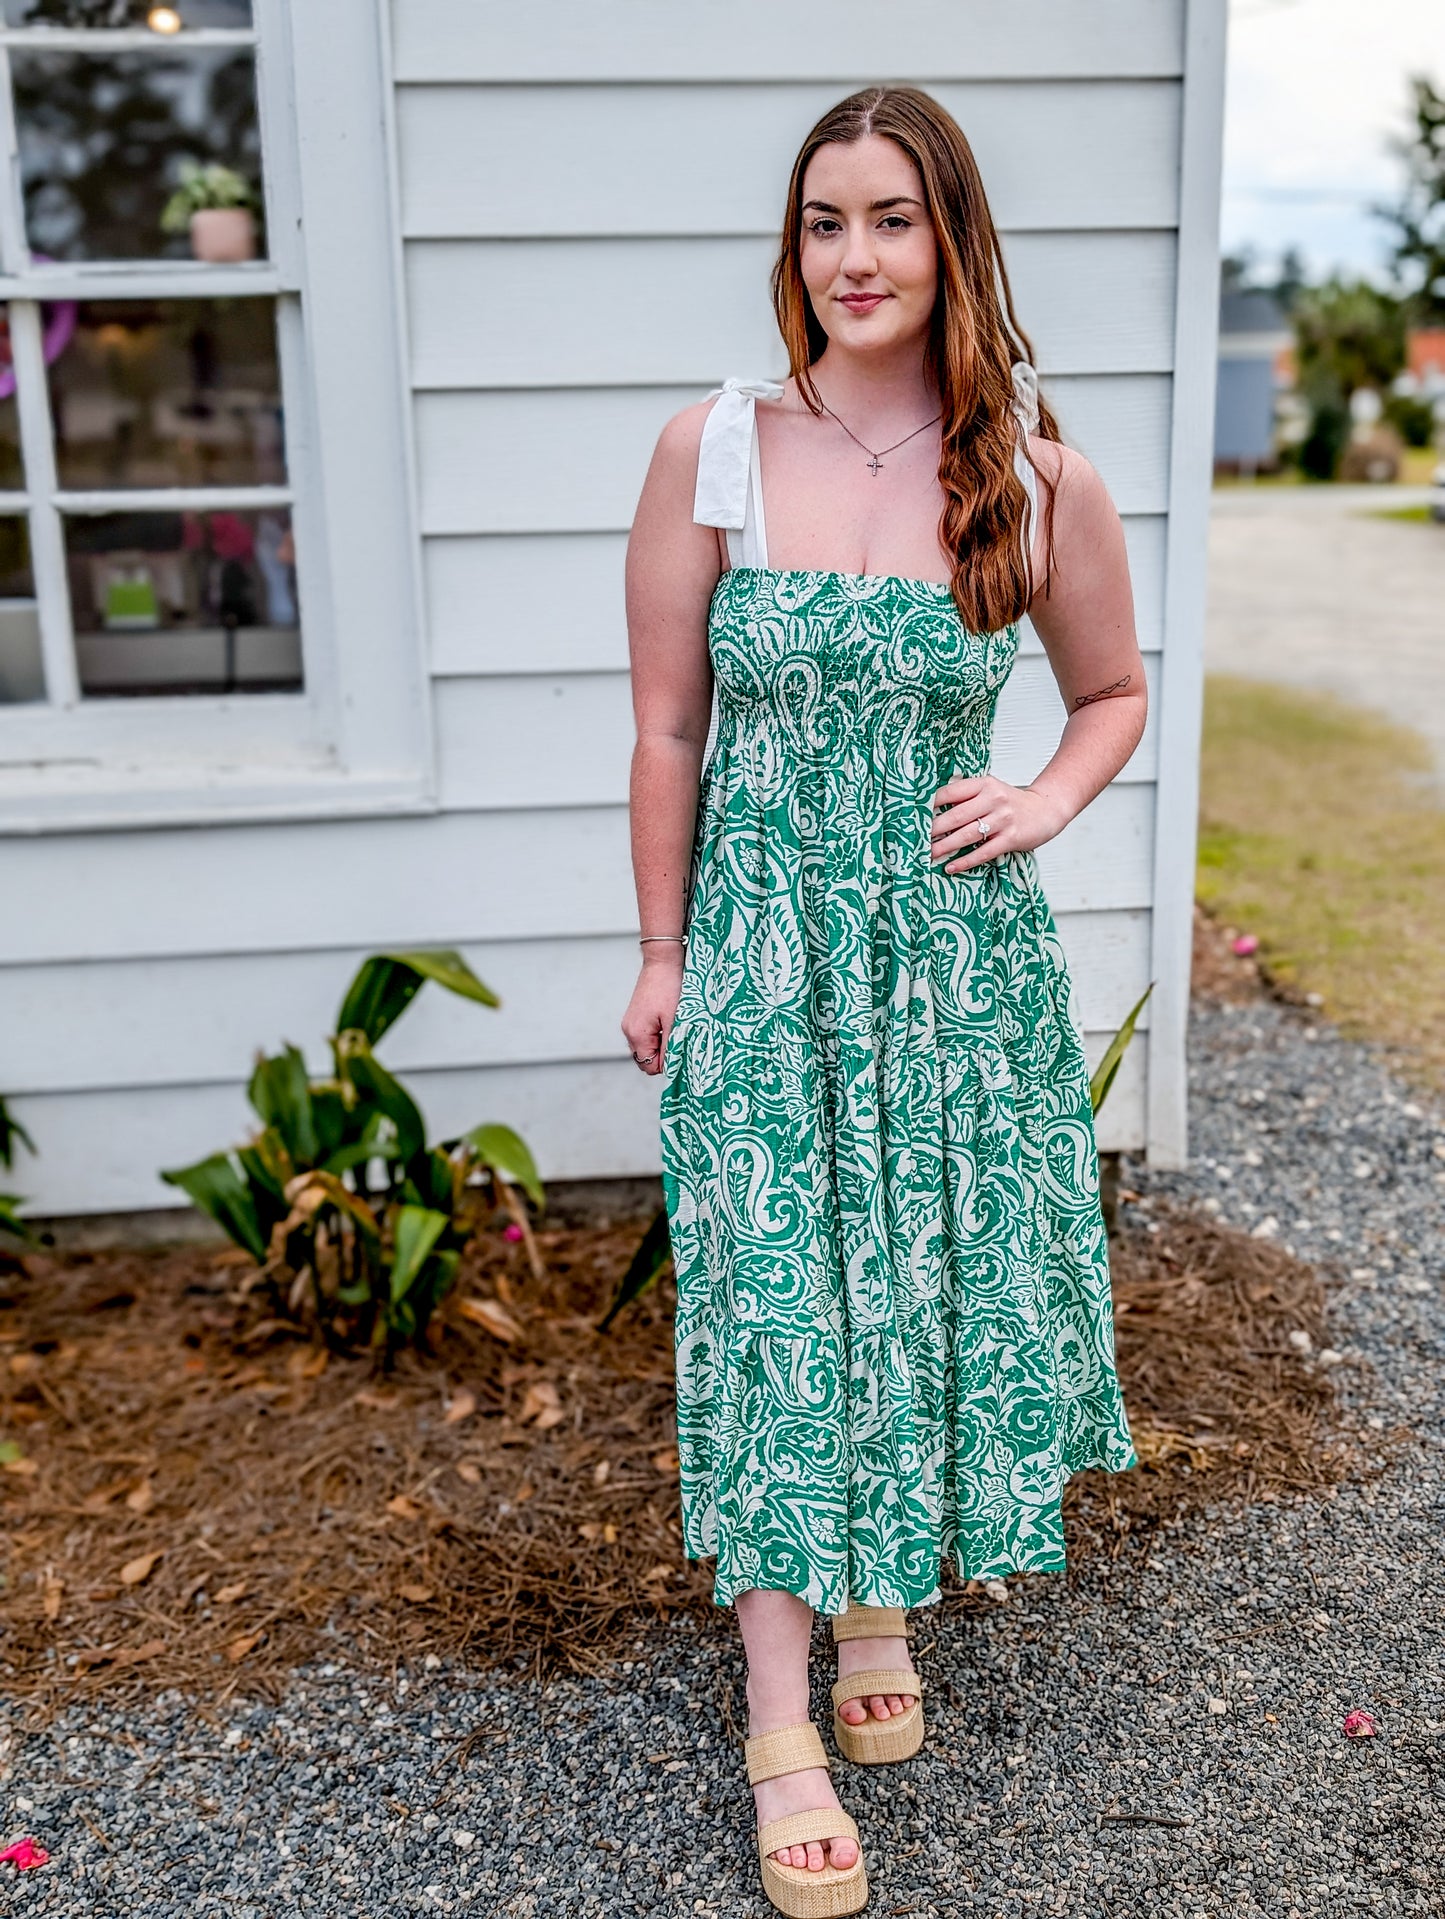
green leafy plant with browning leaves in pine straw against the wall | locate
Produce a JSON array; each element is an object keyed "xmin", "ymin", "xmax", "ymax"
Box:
[{"xmin": 161, "ymin": 950, "xmax": 545, "ymax": 1364}]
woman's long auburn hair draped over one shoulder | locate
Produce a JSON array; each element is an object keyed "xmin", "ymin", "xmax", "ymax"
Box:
[{"xmin": 771, "ymin": 86, "xmax": 1059, "ymax": 633}]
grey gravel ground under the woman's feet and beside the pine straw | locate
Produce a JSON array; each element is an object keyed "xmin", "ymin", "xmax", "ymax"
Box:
[{"xmin": 0, "ymin": 1006, "xmax": 1445, "ymax": 1919}]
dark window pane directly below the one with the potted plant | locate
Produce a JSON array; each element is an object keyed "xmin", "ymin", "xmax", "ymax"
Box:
[{"xmin": 50, "ymin": 299, "xmax": 286, "ymax": 489}]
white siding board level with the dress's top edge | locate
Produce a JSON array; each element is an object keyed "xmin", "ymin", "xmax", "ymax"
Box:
[{"xmin": 424, "ymin": 514, "xmax": 1167, "ymax": 677}]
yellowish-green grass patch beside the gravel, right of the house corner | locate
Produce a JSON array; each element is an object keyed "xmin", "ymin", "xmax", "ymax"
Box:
[{"xmin": 1197, "ymin": 675, "xmax": 1445, "ymax": 1090}]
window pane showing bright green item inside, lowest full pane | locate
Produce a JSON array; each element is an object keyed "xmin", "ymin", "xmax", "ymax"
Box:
[{"xmin": 65, "ymin": 509, "xmax": 301, "ymax": 695}]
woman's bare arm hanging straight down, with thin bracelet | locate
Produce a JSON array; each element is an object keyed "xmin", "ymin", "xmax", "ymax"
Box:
[{"xmin": 622, "ymin": 401, "xmax": 722, "ymax": 1073}]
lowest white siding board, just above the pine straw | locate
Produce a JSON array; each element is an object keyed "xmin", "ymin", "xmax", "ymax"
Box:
[{"xmin": 5, "ymin": 1032, "xmax": 1149, "ymax": 1215}]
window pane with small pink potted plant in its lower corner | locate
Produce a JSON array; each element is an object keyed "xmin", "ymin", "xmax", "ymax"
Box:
[{"xmin": 10, "ymin": 40, "xmax": 263, "ymax": 259}]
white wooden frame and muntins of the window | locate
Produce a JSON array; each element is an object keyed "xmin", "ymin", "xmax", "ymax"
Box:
[{"xmin": 0, "ymin": 0, "xmax": 436, "ymax": 835}]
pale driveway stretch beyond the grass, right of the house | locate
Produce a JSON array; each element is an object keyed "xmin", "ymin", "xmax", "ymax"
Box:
[{"xmin": 1205, "ymin": 486, "xmax": 1445, "ymax": 779}]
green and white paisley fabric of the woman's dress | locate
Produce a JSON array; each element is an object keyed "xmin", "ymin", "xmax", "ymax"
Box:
[{"xmin": 662, "ymin": 566, "xmax": 1134, "ymax": 1614}]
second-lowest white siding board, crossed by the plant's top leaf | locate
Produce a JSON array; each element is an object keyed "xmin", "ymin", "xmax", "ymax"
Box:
[{"xmin": 4, "ymin": 912, "xmax": 1149, "ymax": 1096}]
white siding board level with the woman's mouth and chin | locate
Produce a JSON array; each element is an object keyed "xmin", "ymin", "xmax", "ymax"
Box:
[{"xmin": 407, "ymin": 232, "xmax": 1174, "ymax": 390}]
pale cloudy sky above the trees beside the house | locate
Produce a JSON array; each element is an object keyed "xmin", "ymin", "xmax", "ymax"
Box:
[{"xmin": 1220, "ymin": 0, "xmax": 1445, "ymax": 278}]
